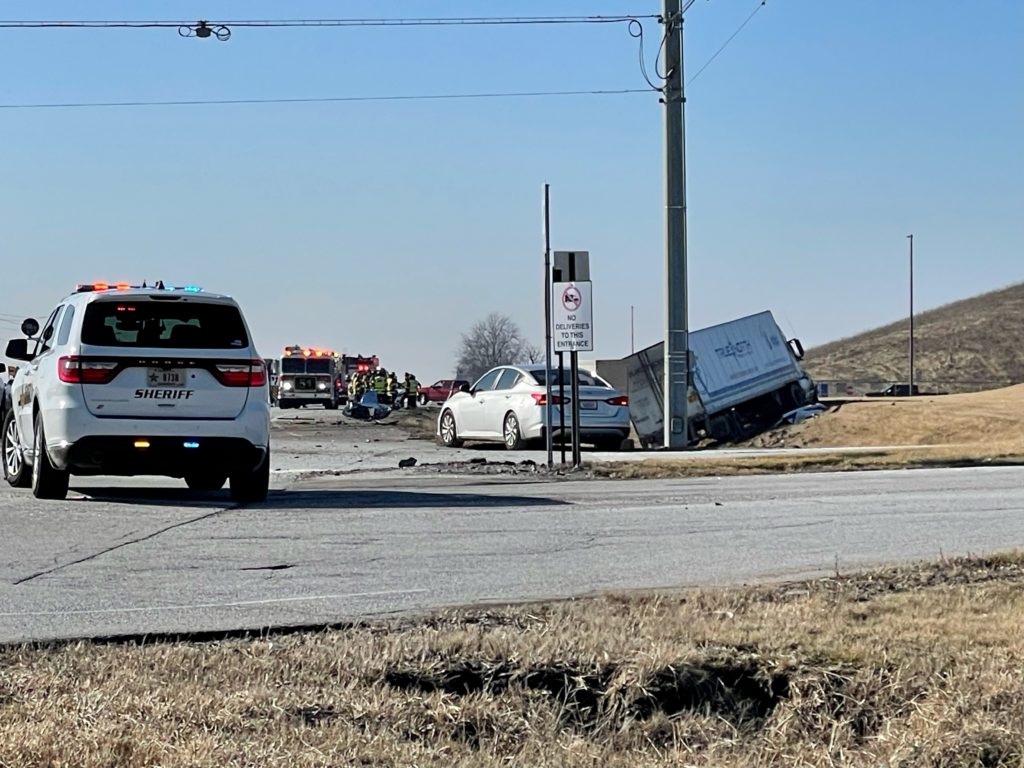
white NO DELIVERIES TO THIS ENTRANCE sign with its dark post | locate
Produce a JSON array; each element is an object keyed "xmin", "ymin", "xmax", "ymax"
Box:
[{"xmin": 551, "ymin": 251, "xmax": 594, "ymax": 467}]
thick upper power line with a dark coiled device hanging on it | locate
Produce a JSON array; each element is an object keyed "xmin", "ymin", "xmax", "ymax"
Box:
[{"xmin": 0, "ymin": 13, "xmax": 658, "ymax": 29}]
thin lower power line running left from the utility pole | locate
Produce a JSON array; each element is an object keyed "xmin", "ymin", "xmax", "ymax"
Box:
[{"xmin": 0, "ymin": 88, "xmax": 650, "ymax": 110}]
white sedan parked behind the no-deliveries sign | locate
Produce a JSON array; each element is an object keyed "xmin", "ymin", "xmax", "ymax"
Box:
[{"xmin": 437, "ymin": 366, "xmax": 630, "ymax": 451}]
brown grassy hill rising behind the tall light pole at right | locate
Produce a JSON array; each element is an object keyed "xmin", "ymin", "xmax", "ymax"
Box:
[{"xmin": 805, "ymin": 283, "xmax": 1024, "ymax": 392}]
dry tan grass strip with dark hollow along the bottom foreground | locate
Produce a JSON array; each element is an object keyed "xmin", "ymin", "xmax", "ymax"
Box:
[{"xmin": 0, "ymin": 554, "xmax": 1024, "ymax": 768}]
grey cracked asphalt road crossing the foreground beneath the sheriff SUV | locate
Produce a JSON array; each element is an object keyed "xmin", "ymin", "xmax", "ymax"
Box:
[{"xmin": 0, "ymin": 468, "xmax": 1024, "ymax": 642}]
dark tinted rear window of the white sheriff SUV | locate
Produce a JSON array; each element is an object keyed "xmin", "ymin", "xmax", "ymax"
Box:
[{"xmin": 82, "ymin": 301, "xmax": 249, "ymax": 349}]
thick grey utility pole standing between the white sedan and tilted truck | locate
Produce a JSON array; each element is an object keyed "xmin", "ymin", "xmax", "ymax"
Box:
[{"xmin": 662, "ymin": 0, "xmax": 690, "ymax": 449}]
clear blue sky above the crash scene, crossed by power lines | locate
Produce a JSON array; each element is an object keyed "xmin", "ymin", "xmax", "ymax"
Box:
[{"xmin": 0, "ymin": 0, "xmax": 1024, "ymax": 379}]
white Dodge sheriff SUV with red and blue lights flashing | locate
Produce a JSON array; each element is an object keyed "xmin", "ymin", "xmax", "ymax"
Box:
[{"xmin": 0, "ymin": 283, "xmax": 270, "ymax": 503}]
